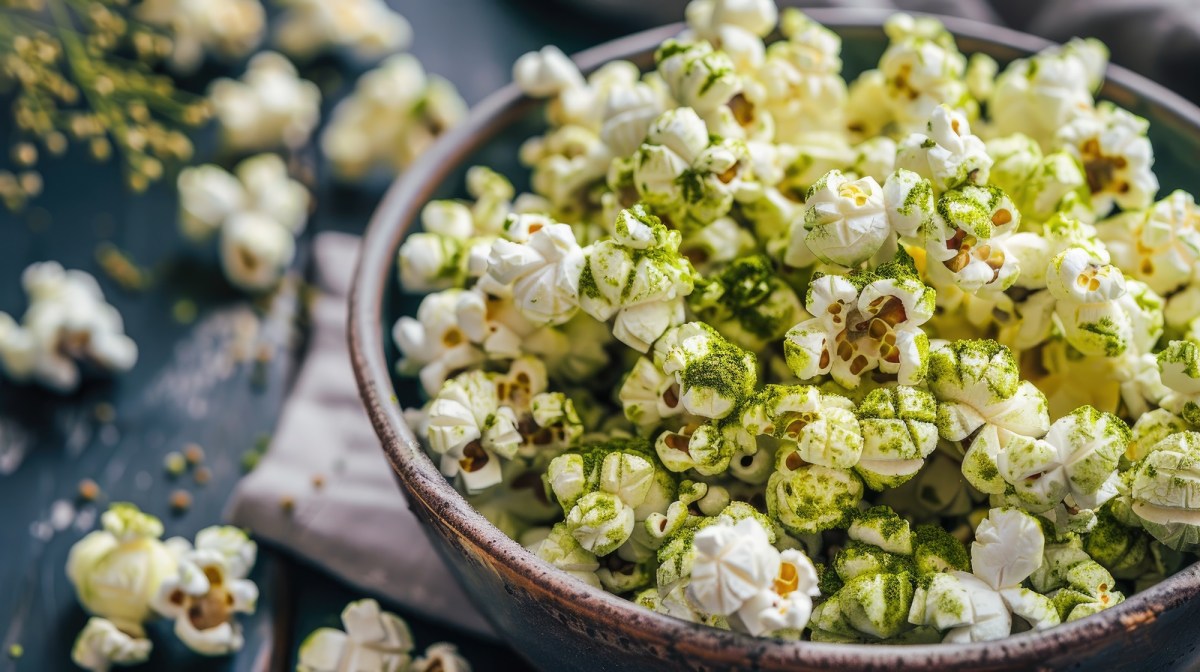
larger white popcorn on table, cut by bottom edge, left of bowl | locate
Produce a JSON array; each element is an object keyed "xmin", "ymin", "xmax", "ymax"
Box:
[{"xmin": 296, "ymin": 599, "xmax": 412, "ymax": 672}]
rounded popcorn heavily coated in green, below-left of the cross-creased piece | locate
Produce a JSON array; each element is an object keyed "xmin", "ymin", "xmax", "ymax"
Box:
[{"xmin": 767, "ymin": 460, "xmax": 863, "ymax": 535}]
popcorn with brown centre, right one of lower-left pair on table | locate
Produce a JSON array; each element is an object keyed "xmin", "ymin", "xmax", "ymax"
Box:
[{"xmin": 154, "ymin": 528, "xmax": 258, "ymax": 655}]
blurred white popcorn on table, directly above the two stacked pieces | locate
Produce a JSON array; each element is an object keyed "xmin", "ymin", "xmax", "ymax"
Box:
[{"xmin": 209, "ymin": 52, "xmax": 320, "ymax": 151}]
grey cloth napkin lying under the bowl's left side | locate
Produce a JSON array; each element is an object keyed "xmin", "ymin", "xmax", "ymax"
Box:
[{"xmin": 226, "ymin": 233, "xmax": 493, "ymax": 637}]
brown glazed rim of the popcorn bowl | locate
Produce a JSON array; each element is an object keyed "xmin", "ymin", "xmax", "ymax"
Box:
[{"xmin": 348, "ymin": 8, "xmax": 1200, "ymax": 667}]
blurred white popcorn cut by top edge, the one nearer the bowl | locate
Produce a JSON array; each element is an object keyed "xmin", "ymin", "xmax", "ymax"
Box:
[{"xmin": 275, "ymin": 0, "xmax": 413, "ymax": 59}]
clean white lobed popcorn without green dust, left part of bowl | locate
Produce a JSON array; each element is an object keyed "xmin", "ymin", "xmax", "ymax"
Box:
[{"xmin": 487, "ymin": 223, "xmax": 586, "ymax": 325}]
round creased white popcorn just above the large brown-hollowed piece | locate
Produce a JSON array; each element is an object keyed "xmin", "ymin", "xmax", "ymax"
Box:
[{"xmin": 792, "ymin": 170, "xmax": 892, "ymax": 266}]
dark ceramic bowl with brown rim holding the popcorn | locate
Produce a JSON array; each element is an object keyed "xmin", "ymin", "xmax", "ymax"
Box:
[{"xmin": 349, "ymin": 10, "xmax": 1200, "ymax": 672}]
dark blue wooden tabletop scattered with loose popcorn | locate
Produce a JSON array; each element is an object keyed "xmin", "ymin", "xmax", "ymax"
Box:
[{"xmin": 0, "ymin": 0, "xmax": 628, "ymax": 672}]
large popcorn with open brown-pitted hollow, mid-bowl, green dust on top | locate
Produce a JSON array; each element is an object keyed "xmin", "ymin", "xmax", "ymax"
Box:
[{"xmin": 784, "ymin": 251, "xmax": 935, "ymax": 389}]
